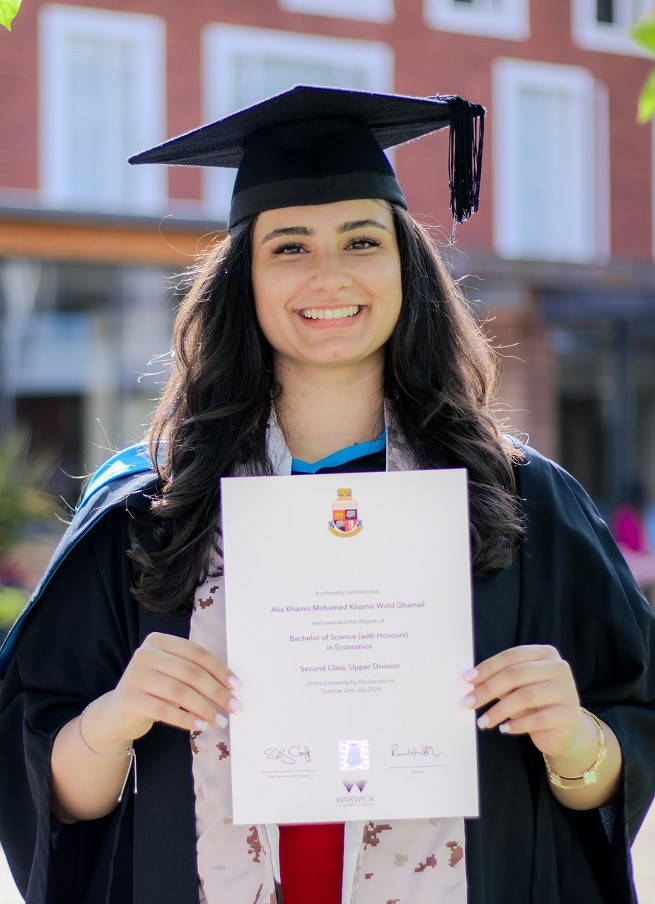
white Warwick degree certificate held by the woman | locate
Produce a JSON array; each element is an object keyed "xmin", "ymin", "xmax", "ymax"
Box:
[{"xmin": 222, "ymin": 470, "xmax": 478, "ymax": 824}]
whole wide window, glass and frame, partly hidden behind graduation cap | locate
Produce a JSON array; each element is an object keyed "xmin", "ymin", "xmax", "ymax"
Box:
[{"xmin": 203, "ymin": 25, "xmax": 393, "ymax": 219}]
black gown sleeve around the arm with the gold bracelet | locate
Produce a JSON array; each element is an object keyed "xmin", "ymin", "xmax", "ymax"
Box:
[{"xmin": 517, "ymin": 450, "xmax": 655, "ymax": 901}]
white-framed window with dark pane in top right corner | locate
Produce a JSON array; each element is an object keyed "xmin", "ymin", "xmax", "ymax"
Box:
[{"xmin": 571, "ymin": 0, "xmax": 653, "ymax": 56}]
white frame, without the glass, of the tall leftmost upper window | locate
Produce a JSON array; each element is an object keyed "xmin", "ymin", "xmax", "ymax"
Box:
[{"xmin": 39, "ymin": 4, "xmax": 167, "ymax": 213}]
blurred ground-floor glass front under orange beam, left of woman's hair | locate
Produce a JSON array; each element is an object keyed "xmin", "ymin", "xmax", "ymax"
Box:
[{"xmin": 0, "ymin": 258, "xmax": 175, "ymax": 502}]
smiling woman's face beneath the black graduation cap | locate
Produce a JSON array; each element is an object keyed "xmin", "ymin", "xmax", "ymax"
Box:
[{"xmin": 252, "ymin": 199, "xmax": 402, "ymax": 376}]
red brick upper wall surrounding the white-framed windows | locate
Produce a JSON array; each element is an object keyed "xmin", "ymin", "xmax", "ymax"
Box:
[{"xmin": 0, "ymin": 0, "xmax": 652, "ymax": 259}]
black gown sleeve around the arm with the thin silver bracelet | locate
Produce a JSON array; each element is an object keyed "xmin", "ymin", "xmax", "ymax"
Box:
[{"xmin": 0, "ymin": 506, "xmax": 138, "ymax": 904}]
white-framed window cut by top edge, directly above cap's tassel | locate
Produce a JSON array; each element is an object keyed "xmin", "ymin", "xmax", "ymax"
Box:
[{"xmin": 424, "ymin": 0, "xmax": 530, "ymax": 41}]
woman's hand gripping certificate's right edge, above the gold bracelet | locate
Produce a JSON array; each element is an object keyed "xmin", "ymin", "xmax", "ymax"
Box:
[{"xmin": 465, "ymin": 644, "xmax": 581, "ymax": 757}]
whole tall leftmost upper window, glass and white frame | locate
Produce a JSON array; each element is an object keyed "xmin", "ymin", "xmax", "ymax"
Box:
[{"xmin": 39, "ymin": 5, "xmax": 166, "ymax": 212}]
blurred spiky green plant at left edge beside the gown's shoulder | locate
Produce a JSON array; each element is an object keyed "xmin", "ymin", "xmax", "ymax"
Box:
[{"xmin": 0, "ymin": 430, "xmax": 55, "ymax": 560}]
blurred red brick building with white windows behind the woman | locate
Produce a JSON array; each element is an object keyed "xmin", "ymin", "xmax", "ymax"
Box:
[{"xmin": 0, "ymin": 0, "xmax": 655, "ymax": 505}]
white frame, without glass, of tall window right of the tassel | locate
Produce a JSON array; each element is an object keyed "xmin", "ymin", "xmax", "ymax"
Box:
[{"xmin": 492, "ymin": 58, "xmax": 610, "ymax": 263}]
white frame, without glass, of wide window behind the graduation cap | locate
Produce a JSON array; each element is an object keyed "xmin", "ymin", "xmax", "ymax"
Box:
[{"xmin": 202, "ymin": 23, "xmax": 394, "ymax": 220}]
